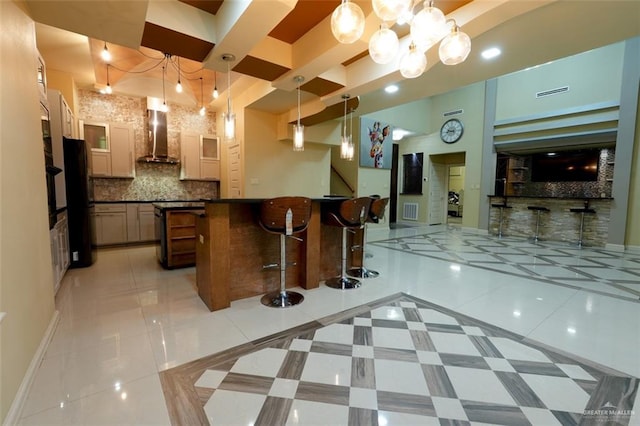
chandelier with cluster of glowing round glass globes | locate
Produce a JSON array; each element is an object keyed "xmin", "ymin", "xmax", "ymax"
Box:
[{"xmin": 331, "ymin": 0, "xmax": 471, "ymax": 78}]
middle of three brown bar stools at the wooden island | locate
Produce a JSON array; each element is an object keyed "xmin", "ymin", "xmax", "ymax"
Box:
[{"xmin": 323, "ymin": 197, "xmax": 371, "ymax": 290}]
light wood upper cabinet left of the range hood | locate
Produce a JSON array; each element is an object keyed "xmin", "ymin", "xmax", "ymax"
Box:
[{"xmin": 80, "ymin": 120, "xmax": 136, "ymax": 178}]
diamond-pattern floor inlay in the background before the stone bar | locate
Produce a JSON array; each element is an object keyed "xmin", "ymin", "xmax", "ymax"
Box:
[{"xmin": 369, "ymin": 228, "xmax": 640, "ymax": 302}]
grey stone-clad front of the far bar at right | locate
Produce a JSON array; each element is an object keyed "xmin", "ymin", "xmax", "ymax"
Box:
[{"xmin": 489, "ymin": 197, "xmax": 611, "ymax": 247}]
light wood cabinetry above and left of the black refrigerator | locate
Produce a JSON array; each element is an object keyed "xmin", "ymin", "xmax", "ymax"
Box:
[{"xmin": 47, "ymin": 89, "xmax": 76, "ymax": 209}]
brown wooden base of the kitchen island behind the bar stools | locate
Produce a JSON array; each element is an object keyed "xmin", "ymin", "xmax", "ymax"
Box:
[{"xmin": 196, "ymin": 197, "xmax": 363, "ymax": 311}]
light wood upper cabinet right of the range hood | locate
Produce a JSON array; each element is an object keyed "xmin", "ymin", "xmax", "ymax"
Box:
[{"xmin": 180, "ymin": 132, "xmax": 220, "ymax": 181}]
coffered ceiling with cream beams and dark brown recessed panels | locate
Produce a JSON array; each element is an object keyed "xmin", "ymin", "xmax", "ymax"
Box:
[{"xmin": 26, "ymin": 0, "xmax": 640, "ymax": 127}]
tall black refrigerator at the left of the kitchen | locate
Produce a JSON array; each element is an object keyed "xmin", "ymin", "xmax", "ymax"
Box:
[{"xmin": 62, "ymin": 138, "xmax": 96, "ymax": 268}]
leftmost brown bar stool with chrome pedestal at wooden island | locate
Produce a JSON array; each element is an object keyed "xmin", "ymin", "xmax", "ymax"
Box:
[{"xmin": 259, "ymin": 197, "xmax": 311, "ymax": 308}]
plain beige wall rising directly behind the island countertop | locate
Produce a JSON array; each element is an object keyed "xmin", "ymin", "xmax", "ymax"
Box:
[{"xmin": 244, "ymin": 108, "xmax": 331, "ymax": 198}]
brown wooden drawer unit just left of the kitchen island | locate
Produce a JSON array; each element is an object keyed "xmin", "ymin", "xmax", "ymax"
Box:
[{"xmin": 165, "ymin": 210, "xmax": 202, "ymax": 268}]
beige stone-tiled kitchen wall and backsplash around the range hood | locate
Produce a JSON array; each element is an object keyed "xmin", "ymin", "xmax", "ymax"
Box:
[{"xmin": 77, "ymin": 90, "xmax": 219, "ymax": 201}]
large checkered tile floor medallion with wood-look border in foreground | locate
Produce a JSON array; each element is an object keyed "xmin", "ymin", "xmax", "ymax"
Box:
[{"xmin": 160, "ymin": 293, "xmax": 638, "ymax": 426}]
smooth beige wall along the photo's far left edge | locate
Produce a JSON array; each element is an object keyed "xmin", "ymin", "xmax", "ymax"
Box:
[{"xmin": 0, "ymin": 1, "xmax": 54, "ymax": 419}]
